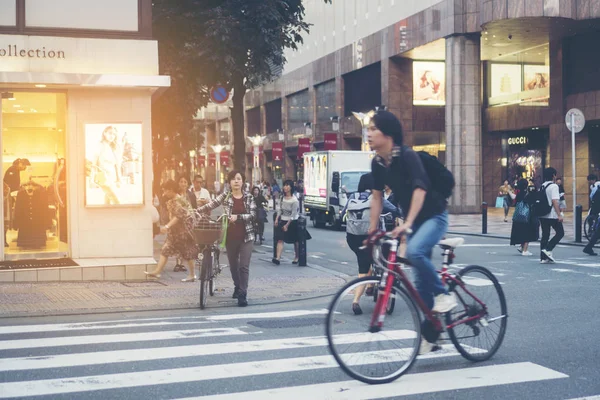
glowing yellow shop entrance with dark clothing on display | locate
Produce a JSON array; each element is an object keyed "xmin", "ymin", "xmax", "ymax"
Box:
[{"xmin": 0, "ymin": 90, "xmax": 69, "ymax": 261}]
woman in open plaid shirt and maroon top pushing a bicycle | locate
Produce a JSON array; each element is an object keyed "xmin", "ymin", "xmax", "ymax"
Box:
[{"xmin": 198, "ymin": 170, "xmax": 256, "ymax": 307}]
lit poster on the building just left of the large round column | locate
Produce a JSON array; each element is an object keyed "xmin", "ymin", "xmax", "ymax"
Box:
[{"xmin": 413, "ymin": 61, "xmax": 446, "ymax": 106}]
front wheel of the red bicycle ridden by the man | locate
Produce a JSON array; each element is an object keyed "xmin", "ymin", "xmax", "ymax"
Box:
[{"xmin": 326, "ymin": 276, "xmax": 421, "ymax": 384}]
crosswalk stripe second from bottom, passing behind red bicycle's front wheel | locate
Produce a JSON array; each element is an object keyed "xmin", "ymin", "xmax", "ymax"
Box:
[{"xmin": 0, "ymin": 348, "xmax": 468, "ymax": 398}]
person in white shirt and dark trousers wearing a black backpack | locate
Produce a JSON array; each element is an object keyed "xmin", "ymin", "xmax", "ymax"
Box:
[{"xmin": 540, "ymin": 167, "xmax": 565, "ymax": 264}]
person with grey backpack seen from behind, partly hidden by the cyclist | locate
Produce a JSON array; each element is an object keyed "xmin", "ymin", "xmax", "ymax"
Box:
[{"xmin": 342, "ymin": 173, "xmax": 400, "ymax": 315}]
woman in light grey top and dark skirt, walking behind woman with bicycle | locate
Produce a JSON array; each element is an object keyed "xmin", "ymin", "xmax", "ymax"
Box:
[{"xmin": 271, "ymin": 180, "xmax": 300, "ymax": 265}]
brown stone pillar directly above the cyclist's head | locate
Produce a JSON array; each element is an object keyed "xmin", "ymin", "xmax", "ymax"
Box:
[{"xmin": 381, "ymin": 58, "xmax": 413, "ymax": 146}]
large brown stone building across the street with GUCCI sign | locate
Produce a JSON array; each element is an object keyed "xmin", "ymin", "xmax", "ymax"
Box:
[{"xmin": 246, "ymin": 0, "xmax": 600, "ymax": 213}]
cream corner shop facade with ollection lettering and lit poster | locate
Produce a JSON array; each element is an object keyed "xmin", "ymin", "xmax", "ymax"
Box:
[{"xmin": 0, "ymin": 0, "xmax": 170, "ymax": 281}]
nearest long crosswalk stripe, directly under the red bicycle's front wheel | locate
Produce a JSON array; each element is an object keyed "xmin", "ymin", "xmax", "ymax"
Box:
[{"xmin": 175, "ymin": 362, "xmax": 568, "ymax": 400}]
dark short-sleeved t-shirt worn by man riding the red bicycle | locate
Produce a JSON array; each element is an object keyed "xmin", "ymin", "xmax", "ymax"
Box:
[{"xmin": 371, "ymin": 147, "xmax": 447, "ymax": 225}]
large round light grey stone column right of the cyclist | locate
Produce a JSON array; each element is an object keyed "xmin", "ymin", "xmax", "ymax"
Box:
[{"xmin": 446, "ymin": 34, "xmax": 482, "ymax": 213}]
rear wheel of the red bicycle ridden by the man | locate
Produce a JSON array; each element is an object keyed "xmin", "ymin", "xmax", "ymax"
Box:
[{"xmin": 446, "ymin": 265, "xmax": 508, "ymax": 361}]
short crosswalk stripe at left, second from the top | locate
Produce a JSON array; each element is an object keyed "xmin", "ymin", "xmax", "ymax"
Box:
[{"xmin": 0, "ymin": 328, "xmax": 247, "ymax": 351}]
